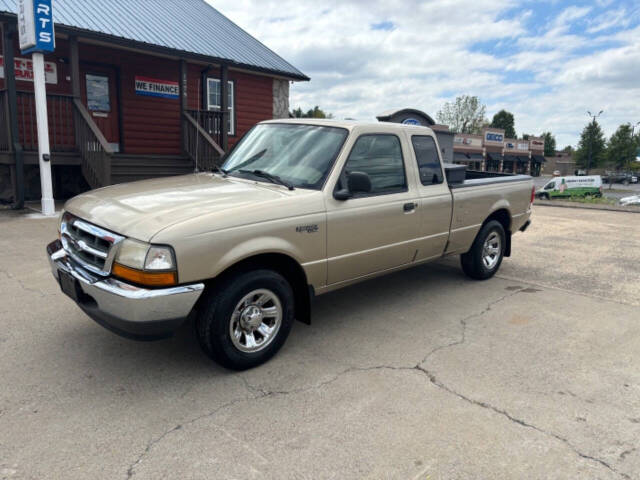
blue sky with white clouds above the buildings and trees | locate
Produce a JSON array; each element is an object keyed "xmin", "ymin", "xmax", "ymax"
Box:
[{"xmin": 207, "ymin": 0, "xmax": 640, "ymax": 148}]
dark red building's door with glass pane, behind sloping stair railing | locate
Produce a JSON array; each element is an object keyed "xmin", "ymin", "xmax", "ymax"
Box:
[{"xmin": 80, "ymin": 65, "xmax": 120, "ymax": 152}]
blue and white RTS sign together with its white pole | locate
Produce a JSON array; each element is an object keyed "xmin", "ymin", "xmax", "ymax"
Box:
[{"xmin": 18, "ymin": 0, "xmax": 56, "ymax": 215}]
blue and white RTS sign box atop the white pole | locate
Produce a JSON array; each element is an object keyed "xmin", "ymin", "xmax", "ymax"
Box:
[{"xmin": 18, "ymin": 0, "xmax": 56, "ymax": 54}]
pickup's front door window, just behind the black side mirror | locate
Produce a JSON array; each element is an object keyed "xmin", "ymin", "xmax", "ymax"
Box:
[{"xmin": 345, "ymin": 134, "xmax": 407, "ymax": 195}]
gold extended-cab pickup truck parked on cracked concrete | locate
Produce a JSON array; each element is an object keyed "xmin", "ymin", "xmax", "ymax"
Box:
[{"xmin": 47, "ymin": 119, "xmax": 534, "ymax": 369}]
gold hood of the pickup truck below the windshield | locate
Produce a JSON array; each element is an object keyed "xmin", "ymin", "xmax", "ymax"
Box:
[{"xmin": 64, "ymin": 173, "xmax": 294, "ymax": 241}]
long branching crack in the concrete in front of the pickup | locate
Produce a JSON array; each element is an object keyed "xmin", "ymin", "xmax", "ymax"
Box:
[{"xmin": 126, "ymin": 287, "xmax": 631, "ymax": 480}]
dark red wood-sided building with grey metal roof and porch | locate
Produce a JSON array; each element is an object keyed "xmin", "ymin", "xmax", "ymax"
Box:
[{"xmin": 0, "ymin": 0, "xmax": 308, "ymax": 201}]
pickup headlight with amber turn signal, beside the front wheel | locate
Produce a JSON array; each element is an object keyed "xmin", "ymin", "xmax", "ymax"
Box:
[{"xmin": 112, "ymin": 238, "xmax": 178, "ymax": 287}]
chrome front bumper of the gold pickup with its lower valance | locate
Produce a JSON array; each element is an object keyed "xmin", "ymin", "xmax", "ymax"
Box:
[{"xmin": 47, "ymin": 240, "xmax": 204, "ymax": 340}]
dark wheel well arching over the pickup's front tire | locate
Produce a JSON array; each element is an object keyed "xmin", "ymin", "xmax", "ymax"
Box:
[{"xmin": 207, "ymin": 253, "xmax": 313, "ymax": 324}]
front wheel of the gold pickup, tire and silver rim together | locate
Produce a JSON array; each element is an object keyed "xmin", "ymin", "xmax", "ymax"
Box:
[{"xmin": 196, "ymin": 270, "xmax": 294, "ymax": 370}]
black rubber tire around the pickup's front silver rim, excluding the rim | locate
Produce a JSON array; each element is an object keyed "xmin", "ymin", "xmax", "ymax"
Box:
[{"xmin": 195, "ymin": 270, "xmax": 294, "ymax": 370}]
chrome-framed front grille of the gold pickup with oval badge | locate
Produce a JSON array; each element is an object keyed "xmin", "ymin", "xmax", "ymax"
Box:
[{"xmin": 60, "ymin": 213, "xmax": 124, "ymax": 275}]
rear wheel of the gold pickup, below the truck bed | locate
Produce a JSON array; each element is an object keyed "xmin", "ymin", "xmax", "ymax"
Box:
[{"xmin": 460, "ymin": 220, "xmax": 506, "ymax": 280}]
